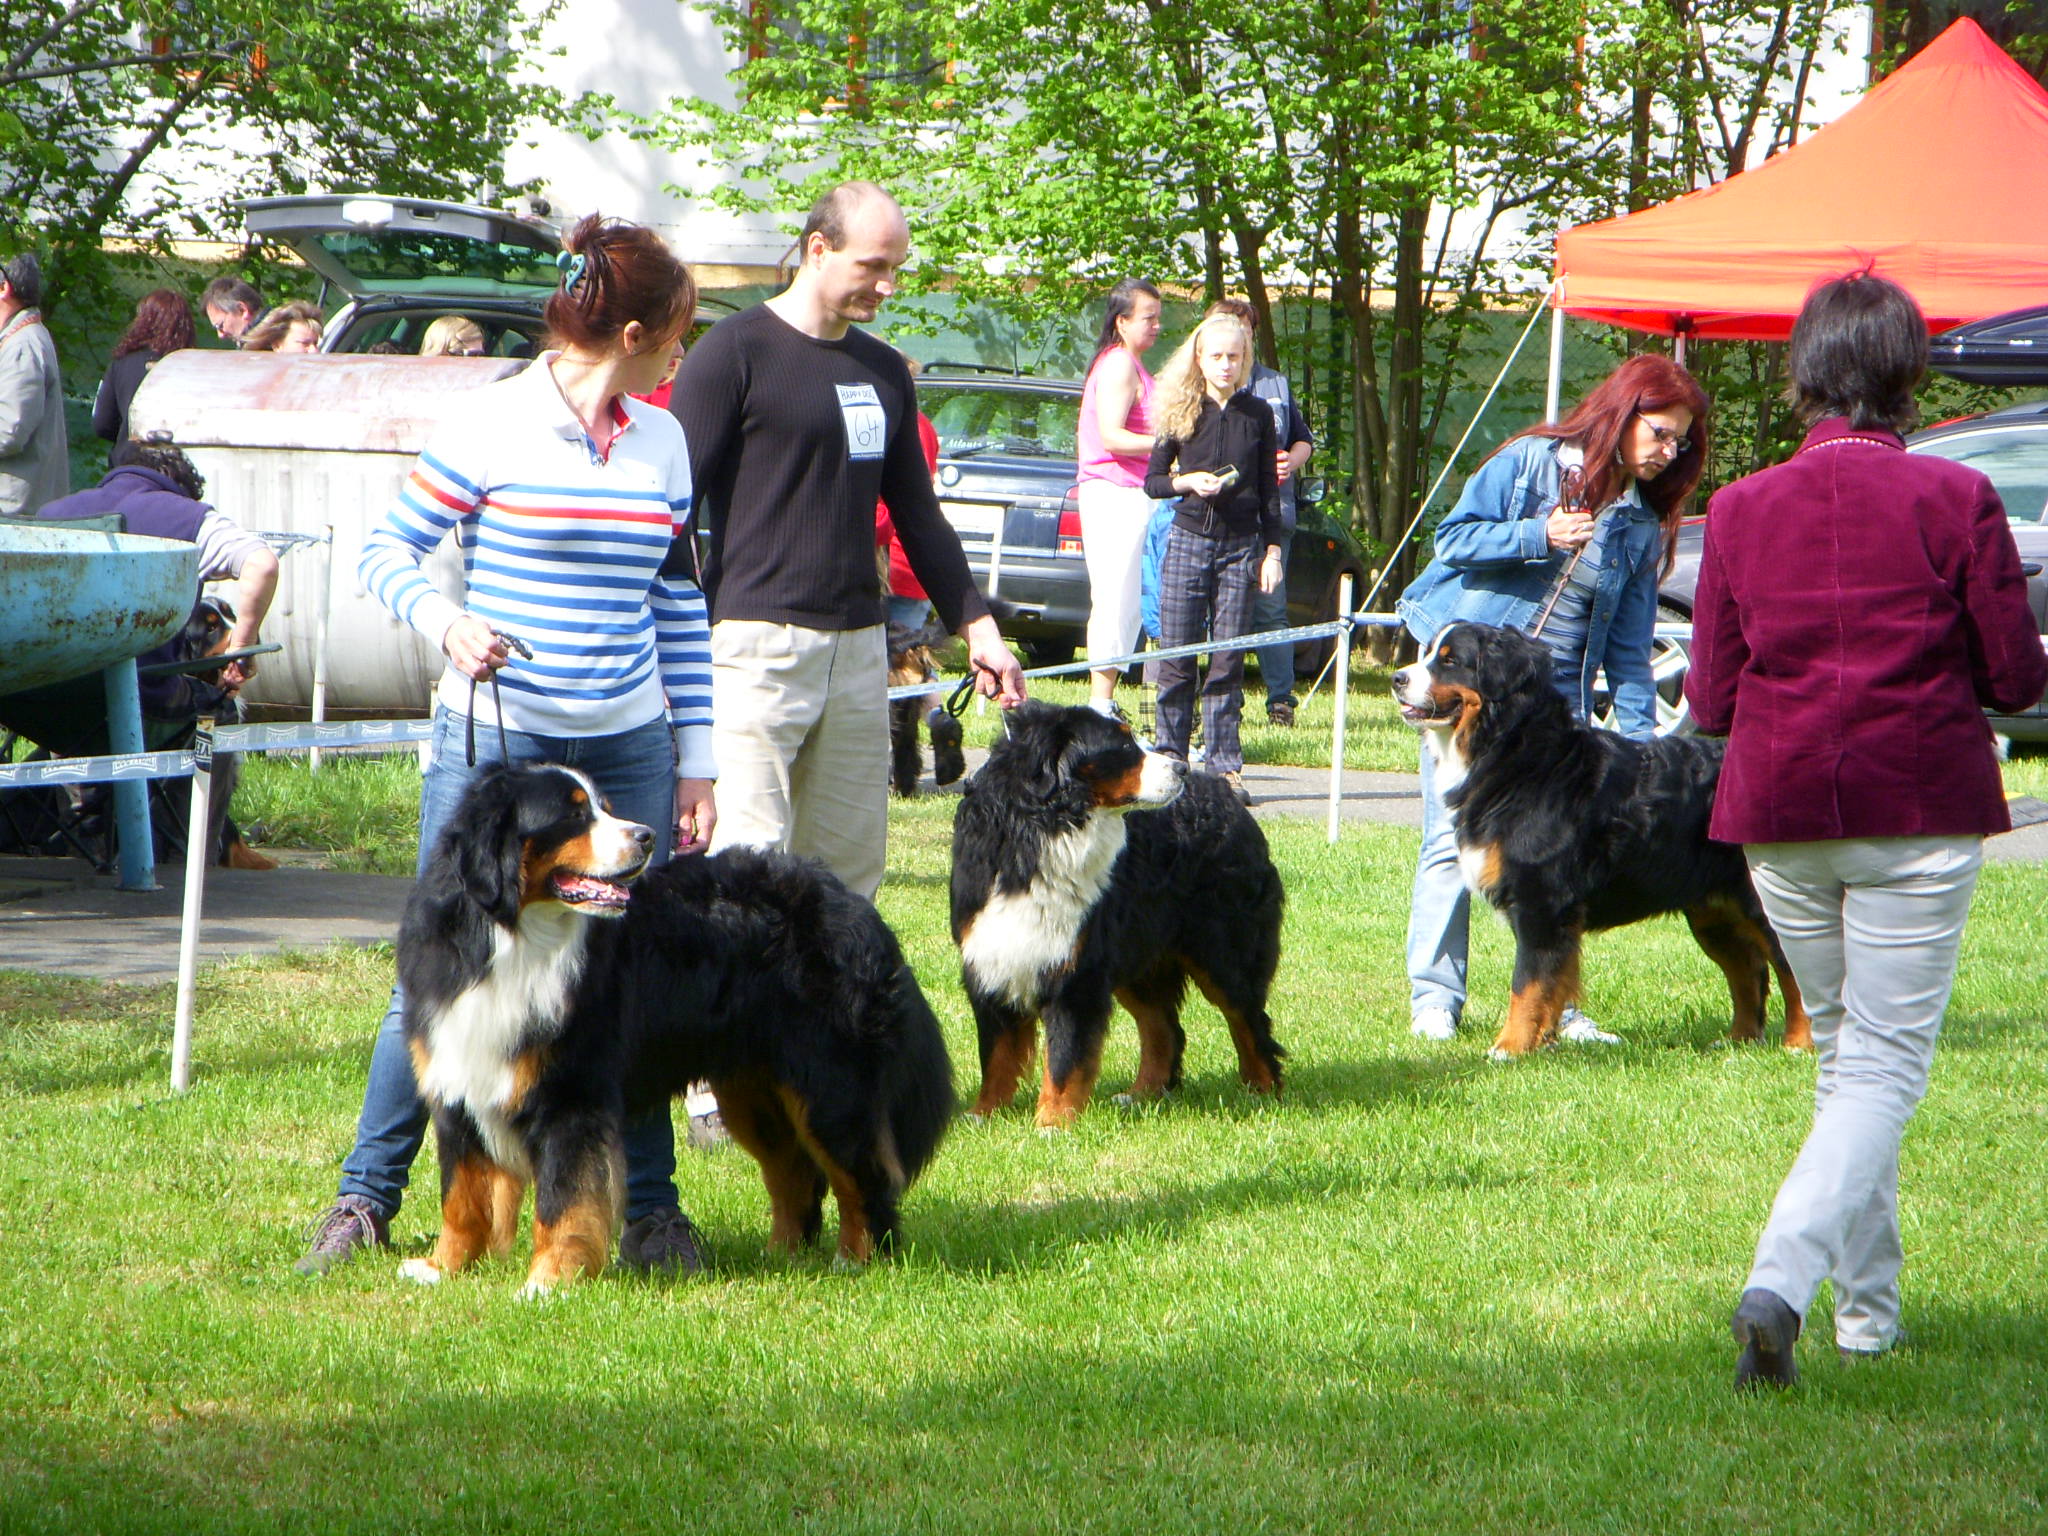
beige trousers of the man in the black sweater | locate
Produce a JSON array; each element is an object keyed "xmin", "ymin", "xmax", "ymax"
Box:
[{"xmin": 711, "ymin": 618, "xmax": 889, "ymax": 901}]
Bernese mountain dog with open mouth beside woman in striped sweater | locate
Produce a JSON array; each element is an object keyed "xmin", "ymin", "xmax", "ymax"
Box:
[{"xmin": 397, "ymin": 766, "xmax": 952, "ymax": 1294}]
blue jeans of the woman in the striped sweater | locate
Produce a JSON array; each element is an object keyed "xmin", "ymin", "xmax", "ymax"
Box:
[{"xmin": 340, "ymin": 709, "xmax": 676, "ymax": 1221}]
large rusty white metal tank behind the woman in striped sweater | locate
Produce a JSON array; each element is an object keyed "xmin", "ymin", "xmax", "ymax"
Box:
[{"xmin": 129, "ymin": 350, "xmax": 526, "ymax": 713}]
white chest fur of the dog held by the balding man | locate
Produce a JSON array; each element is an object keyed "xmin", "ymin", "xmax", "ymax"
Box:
[{"xmin": 961, "ymin": 813, "xmax": 1124, "ymax": 1008}]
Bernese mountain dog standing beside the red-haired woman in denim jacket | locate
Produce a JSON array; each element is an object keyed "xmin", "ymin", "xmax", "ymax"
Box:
[{"xmin": 1393, "ymin": 623, "xmax": 1812, "ymax": 1059}]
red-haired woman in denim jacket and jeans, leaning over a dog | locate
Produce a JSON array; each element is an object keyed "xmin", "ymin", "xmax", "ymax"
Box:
[{"xmin": 1397, "ymin": 356, "xmax": 1708, "ymax": 1044}]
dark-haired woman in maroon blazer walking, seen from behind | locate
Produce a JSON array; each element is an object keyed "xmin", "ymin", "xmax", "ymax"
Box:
[{"xmin": 1686, "ymin": 274, "xmax": 2048, "ymax": 1389}]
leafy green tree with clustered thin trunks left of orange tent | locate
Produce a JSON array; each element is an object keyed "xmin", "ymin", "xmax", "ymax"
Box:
[{"xmin": 637, "ymin": 0, "xmax": 1875, "ymax": 582}]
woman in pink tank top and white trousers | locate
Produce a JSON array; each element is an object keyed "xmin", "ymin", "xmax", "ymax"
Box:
[{"xmin": 1075, "ymin": 276, "xmax": 1159, "ymax": 715}]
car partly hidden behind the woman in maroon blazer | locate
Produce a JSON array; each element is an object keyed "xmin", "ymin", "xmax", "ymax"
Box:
[{"xmin": 1657, "ymin": 401, "xmax": 2048, "ymax": 741}]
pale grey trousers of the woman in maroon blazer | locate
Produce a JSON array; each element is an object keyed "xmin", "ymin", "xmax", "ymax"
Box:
[{"xmin": 1743, "ymin": 838, "xmax": 1985, "ymax": 1352}]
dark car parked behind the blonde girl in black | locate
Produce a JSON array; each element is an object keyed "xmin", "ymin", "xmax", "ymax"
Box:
[{"xmin": 918, "ymin": 362, "xmax": 1366, "ymax": 672}]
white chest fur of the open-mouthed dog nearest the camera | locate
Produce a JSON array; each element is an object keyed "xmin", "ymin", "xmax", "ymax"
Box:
[{"xmin": 420, "ymin": 905, "xmax": 590, "ymax": 1180}]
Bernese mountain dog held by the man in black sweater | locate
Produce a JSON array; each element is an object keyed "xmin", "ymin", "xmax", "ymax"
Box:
[{"xmin": 952, "ymin": 702, "xmax": 1286, "ymax": 1128}]
